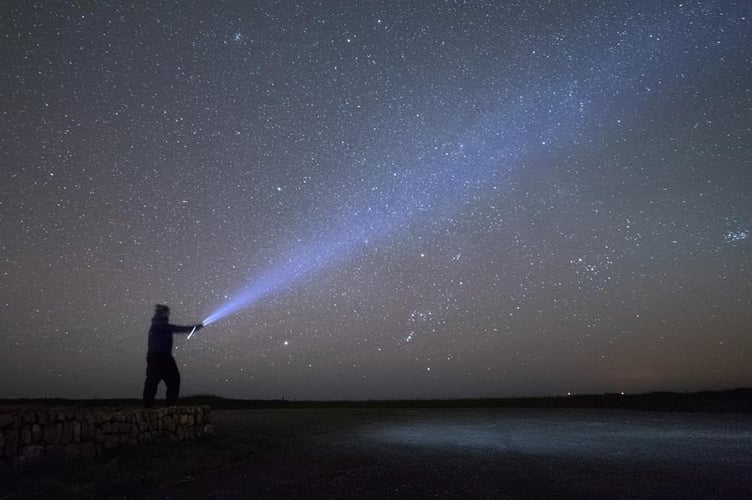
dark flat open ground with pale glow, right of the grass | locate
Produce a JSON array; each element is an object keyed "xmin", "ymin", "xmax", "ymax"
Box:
[{"xmin": 129, "ymin": 409, "xmax": 752, "ymax": 499}]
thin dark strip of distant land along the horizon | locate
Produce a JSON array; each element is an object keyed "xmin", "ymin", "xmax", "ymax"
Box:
[{"xmin": 0, "ymin": 388, "xmax": 752, "ymax": 413}]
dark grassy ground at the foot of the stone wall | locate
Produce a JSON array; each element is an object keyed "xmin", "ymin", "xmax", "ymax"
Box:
[{"xmin": 0, "ymin": 431, "xmax": 273, "ymax": 500}]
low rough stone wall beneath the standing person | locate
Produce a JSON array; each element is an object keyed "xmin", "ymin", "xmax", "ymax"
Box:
[{"xmin": 0, "ymin": 406, "xmax": 213, "ymax": 466}]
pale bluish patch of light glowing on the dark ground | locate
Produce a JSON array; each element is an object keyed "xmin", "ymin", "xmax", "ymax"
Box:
[{"xmin": 361, "ymin": 410, "xmax": 752, "ymax": 462}]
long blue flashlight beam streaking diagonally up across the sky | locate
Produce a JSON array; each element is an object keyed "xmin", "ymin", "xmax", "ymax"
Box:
[{"xmin": 203, "ymin": 7, "xmax": 748, "ymax": 325}]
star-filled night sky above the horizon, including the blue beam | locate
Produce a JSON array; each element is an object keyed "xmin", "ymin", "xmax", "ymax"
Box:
[{"xmin": 0, "ymin": 0, "xmax": 752, "ymax": 399}]
